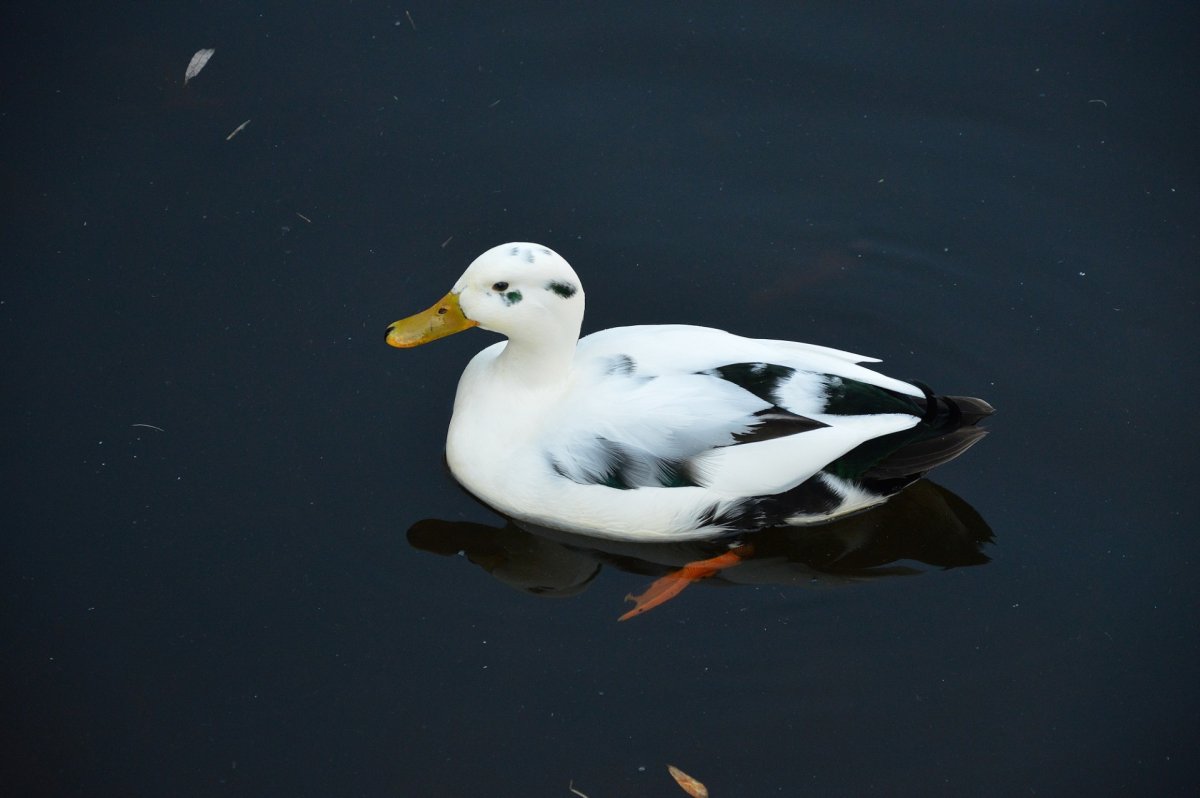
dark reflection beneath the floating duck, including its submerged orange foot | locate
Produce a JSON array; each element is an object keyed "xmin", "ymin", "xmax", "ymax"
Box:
[{"xmin": 408, "ymin": 480, "xmax": 992, "ymax": 620}]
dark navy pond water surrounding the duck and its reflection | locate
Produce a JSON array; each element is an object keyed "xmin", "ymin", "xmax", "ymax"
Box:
[{"xmin": 0, "ymin": 2, "xmax": 1200, "ymax": 798}]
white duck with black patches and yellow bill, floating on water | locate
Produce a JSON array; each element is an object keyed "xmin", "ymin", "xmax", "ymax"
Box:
[{"xmin": 388, "ymin": 244, "xmax": 992, "ymax": 541}]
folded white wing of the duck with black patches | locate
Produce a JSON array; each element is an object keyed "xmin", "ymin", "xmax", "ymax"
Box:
[{"xmin": 542, "ymin": 325, "xmax": 926, "ymax": 499}]
